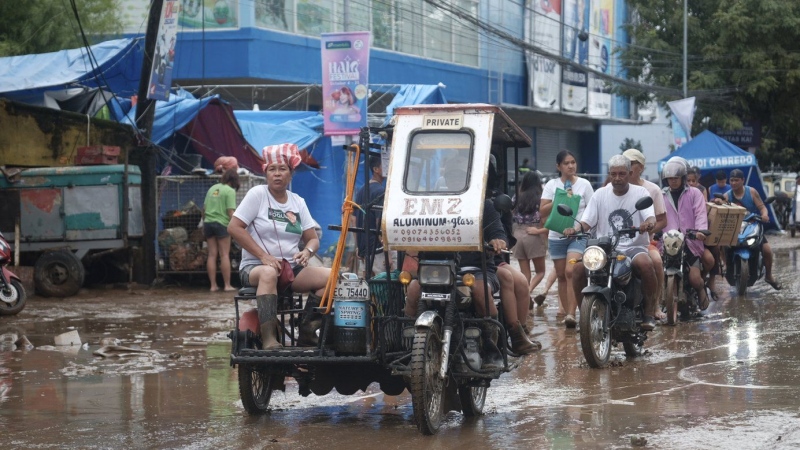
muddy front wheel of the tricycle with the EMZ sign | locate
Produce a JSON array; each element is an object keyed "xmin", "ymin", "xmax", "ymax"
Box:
[{"xmin": 410, "ymin": 323, "xmax": 444, "ymax": 435}]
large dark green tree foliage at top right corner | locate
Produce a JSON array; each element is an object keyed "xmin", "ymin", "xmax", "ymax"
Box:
[{"xmin": 620, "ymin": 0, "xmax": 800, "ymax": 168}]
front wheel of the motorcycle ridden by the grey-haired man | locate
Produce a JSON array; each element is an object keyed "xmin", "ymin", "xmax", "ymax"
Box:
[{"xmin": 580, "ymin": 295, "xmax": 611, "ymax": 368}]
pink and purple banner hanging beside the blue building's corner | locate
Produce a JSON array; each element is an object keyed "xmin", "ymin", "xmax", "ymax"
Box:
[{"xmin": 321, "ymin": 31, "xmax": 370, "ymax": 136}]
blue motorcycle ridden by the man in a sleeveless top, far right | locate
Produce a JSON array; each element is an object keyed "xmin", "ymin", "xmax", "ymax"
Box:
[{"xmin": 716, "ymin": 194, "xmax": 775, "ymax": 297}]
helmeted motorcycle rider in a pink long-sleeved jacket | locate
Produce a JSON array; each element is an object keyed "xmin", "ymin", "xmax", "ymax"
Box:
[{"xmin": 661, "ymin": 159, "xmax": 714, "ymax": 311}]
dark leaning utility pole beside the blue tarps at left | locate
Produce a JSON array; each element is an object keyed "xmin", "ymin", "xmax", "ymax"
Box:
[{"xmin": 131, "ymin": 0, "xmax": 164, "ymax": 284}]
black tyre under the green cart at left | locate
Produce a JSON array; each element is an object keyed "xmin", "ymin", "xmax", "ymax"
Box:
[{"xmin": 33, "ymin": 250, "xmax": 86, "ymax": 297}]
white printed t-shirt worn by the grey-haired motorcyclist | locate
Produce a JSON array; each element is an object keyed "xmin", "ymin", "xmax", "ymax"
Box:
[{"xmin": 581, "ymin": 184, "xmax": 655, "ymax": 251}]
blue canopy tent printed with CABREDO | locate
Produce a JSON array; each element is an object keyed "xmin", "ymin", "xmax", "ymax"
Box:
[{"xmin": 658, "ymin": 131, "xmax": 780, "ymax": 230}]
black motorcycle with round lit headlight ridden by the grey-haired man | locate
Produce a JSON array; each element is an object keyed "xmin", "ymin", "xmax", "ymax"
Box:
[{"xmin": 557, "ymin": 197, "xmax": 653, "ymax": 368}]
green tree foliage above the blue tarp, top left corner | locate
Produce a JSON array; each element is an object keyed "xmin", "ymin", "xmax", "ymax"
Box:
[{"xmin": 0, "ymin": 0, "xmax": 122, "ymax": 56}]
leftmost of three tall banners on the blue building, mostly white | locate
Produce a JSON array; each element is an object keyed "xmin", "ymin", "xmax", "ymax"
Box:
[{"xmin": 526, "ymin": 0, "xmax": 561, "ymax": 109}]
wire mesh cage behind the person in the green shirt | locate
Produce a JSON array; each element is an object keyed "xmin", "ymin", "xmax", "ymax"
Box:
[{"xmin": 156, "ymin": 175, "xmax": 264, "ymax": 274}]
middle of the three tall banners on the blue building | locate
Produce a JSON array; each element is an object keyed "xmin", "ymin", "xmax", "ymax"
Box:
[{"xmin": 561, "ymin": 0, "xmax": 589, "ymax": 113}]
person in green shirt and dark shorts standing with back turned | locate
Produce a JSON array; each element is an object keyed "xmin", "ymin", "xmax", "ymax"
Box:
[{"xmin": 203, "ymin": 169, "xmax": 239, "ymax": 291}]
